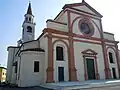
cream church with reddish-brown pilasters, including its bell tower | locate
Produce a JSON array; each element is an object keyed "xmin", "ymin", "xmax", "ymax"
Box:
[{"xmin": 6, "ymin": 0, "xmax": 120, "ymax": 87}]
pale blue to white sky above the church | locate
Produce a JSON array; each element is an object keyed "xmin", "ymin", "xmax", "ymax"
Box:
[{"xmin": 0, "ymin": 0, "xmax": 120, "ymax": 67}]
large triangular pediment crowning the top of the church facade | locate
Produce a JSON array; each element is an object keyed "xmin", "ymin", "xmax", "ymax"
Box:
[{"xmin": 63, "ymin": 2, "xmax": 103, "ymax": 18}]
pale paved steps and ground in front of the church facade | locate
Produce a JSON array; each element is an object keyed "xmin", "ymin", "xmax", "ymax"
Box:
[{"xmin": 40, "ymin": 80, "xmax": 120, "ymax": 90}]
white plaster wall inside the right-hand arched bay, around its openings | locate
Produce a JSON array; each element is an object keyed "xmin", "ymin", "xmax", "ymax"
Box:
[{"xmin": 107, "ymin": 48, "xmax": 119, "ymax": 78}]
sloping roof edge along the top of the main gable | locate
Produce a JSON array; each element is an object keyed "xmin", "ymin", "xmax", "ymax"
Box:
[{"xmin": 63, "ymin": 0, "xmax": 103, "ymax": 18}]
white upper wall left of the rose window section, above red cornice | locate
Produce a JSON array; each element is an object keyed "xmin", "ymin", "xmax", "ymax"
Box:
[{"xmin": 47, "ymin": 21, "xmax": 68, "ymax": 32}]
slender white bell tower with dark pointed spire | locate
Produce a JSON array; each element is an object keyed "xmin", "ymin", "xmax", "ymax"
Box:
[{"xmin": 21, "ymin": 2, "xmax": 35, "ymax": 43}]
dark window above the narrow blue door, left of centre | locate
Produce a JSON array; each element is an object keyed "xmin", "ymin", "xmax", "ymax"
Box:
[{"xmin": 56, "ymin": 46, "xmax": 64, "ymax": 61}]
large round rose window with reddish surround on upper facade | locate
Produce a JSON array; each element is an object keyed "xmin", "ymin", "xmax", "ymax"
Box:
[{"xmin": 78, "ymin": 18, "xmax": 94, "ymax": 36}]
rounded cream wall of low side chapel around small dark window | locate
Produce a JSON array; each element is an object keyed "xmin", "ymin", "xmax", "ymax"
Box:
[{"xmin": 19, "ymin": 51, "xmax": 45, "ymax": 87}]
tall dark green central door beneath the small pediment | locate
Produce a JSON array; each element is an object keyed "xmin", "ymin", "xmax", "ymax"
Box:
[{"xmin": 86, "ymin": 58, "xmax": 95, "ymax": 80}]
